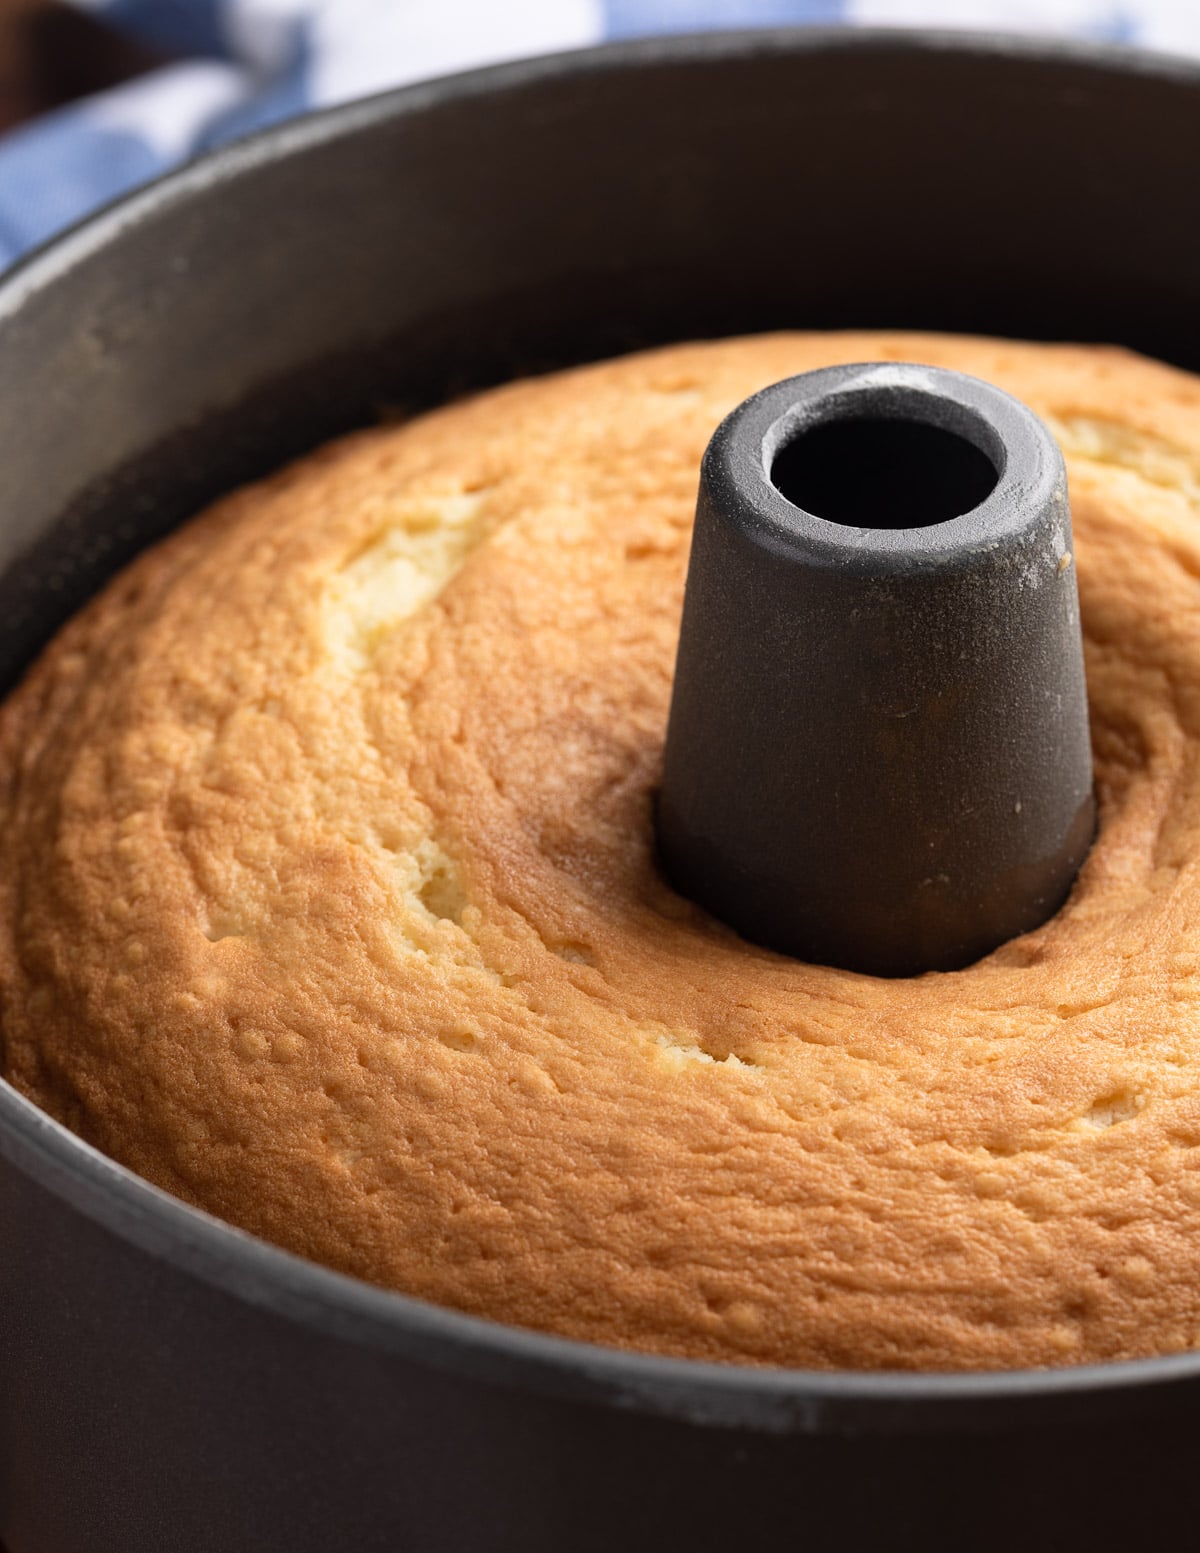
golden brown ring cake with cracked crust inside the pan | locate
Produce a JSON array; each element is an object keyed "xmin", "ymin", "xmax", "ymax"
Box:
[{"xmin": 0, "ymin": 335, "xmax": 1200, "ymax": 1368}]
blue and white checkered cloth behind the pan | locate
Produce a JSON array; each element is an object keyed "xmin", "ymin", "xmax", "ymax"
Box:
[{"xmin": 0, "ymin": 0, "xmax": 1200, "ymax": 269}]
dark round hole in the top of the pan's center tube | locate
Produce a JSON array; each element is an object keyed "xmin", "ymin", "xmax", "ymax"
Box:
[{"xmin": 770, "ymin": 416, "xmax": 1000, "ymax": 528}]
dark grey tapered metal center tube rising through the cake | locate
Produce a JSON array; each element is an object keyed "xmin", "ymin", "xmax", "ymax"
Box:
[{"xmin": 658, "ymin": 363, "xmax": 1096, "ymax": 977}]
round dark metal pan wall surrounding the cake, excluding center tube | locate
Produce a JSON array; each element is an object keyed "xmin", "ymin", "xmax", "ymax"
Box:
[{"xmin": 0, "ymin": 33, "xmax": 1200, "ymax": 1553}]
